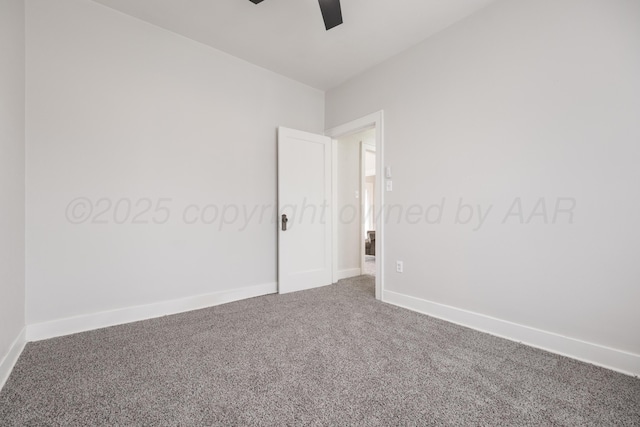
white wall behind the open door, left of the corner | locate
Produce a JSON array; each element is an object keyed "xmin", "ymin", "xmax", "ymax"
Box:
[{"xmin": 26, "ymin": 0, "xmax": 324, "ymax": 325}]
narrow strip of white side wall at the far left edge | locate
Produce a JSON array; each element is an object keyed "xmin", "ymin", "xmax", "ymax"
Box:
[{"xmin": 0, "ymin": 0, "xmax": 25, "ymax": 387}]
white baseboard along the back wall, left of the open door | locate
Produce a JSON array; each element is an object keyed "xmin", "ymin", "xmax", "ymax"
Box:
[{"xmin": 26, "ymin": 283, "xmax": 278, "ymax": 341}]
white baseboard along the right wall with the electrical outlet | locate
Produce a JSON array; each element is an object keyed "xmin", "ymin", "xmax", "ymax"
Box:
[{"xmin": 383, "ymin": 291, "xmax": 640, "ymax": 376}]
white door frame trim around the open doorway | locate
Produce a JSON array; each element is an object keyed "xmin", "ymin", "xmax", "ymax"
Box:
[{"xmin": 324, "ymin": 110, "xmax": 386, "ymax": 300}]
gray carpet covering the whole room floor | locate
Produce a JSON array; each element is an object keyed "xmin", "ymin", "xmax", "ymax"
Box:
[{"xmin": 0, "ymin": 276, "xmax": 640, "ymax": 426}]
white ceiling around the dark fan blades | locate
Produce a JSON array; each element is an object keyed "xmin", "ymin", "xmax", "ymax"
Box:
[{"xmin": 94, "ymin": 0, "xmax": 494, "ymax": 90}]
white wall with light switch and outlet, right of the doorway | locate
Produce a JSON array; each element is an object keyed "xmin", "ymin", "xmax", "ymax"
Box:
[{"xmin": 326, "ymin": 0, "xmax": 640, "ymax": 362}]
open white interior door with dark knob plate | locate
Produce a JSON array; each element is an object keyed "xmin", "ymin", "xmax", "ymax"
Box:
[{"xmin": 278, "ymin": 127, "xmax": 333, "ymax": 294}]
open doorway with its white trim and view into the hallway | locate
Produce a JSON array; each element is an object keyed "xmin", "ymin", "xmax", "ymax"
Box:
[{"xmin": 325, "ymin": 111, "xmax": 384, "ymax": 300}]
